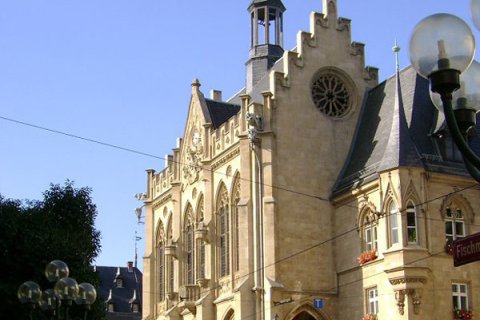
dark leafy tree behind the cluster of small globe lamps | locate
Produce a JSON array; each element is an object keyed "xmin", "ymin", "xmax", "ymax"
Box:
[{"xmin": 0, "ymin": 181, "xmax": 105, "ymax": 319}]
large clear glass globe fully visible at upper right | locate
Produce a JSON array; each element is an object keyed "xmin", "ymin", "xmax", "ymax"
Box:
[{"xmin": 410, "ymin": 13, "xmax": 475, "ymax": 78}]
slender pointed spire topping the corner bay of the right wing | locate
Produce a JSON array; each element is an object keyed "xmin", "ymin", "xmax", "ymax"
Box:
[{"xmin": 378, "ymin": 42, "xmax": 422, "ymax": 172}]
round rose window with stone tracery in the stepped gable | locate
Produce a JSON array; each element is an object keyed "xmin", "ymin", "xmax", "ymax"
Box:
[{"xmin": 311, "ymin": 70, "xmax": 353, "ymax": 119}]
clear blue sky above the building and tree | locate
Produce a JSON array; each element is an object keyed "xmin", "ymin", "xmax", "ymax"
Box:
[{"xmin": 0, "ymin": 0, "xmax": 479, "ymax": 267}]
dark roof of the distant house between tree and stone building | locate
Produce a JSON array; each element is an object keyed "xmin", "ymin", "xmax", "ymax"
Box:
[{"xmin": 96, "ymin": 266, "xmax": 142, "ymax": 320}]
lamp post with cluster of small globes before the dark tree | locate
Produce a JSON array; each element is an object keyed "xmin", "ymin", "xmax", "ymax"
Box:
[{"xmin": 17, "ymin": 260, "xmax": 97, "ymax": 320}]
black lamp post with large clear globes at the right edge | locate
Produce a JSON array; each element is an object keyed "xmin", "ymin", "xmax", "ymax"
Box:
[{"xmin": 410, "ymin": 0, "xmax": 480, "ymax": 182}]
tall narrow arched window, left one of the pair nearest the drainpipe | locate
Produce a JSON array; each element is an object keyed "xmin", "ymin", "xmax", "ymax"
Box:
[{"xmin": 217, "ymin": 185, "xmax": 230, "ymax": 277}]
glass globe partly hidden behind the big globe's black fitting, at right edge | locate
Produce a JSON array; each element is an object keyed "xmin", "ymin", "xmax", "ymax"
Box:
[{"xmin": 430, "ymin": 60, "xmax": 480, "ymax": 113}]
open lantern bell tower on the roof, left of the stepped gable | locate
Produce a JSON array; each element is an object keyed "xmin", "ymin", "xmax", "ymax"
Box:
[{"xmin": 246, "ymin": 0, "xmax": 286, "ymax": 93}]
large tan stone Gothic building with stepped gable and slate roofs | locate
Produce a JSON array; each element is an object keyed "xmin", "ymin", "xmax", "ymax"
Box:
[{"xmin": 143, "ymin": 0, "xmax": 480, "ymax": 320}]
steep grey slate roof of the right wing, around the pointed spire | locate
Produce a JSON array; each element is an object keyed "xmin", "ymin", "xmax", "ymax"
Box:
[{"xmin": 332, "ymin": 67, "xmax": 480, "ymax": 197}]
